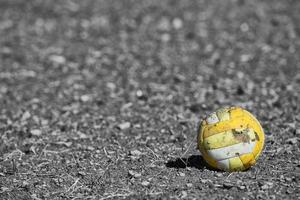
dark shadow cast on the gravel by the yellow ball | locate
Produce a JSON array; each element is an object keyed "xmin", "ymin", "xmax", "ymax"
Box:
[{"xmin": 166, "ymin": 155, "xmax": 217, "ymax": 171}]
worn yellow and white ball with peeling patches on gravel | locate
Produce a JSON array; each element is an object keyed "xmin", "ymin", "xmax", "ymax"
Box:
[{"xmin": 198, "ymin": 107, "xmax": 265, "ymax": 171}]
